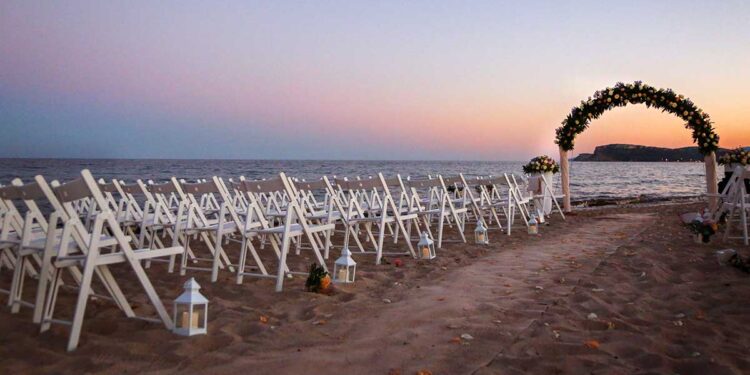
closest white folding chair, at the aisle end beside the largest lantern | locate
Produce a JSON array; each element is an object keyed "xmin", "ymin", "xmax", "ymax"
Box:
[{"xmin": 40, "ymin": 169, "xmax": 183, "ymax": 351}]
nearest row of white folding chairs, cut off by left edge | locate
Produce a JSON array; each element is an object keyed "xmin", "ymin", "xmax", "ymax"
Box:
[{"xmin": 0, "ymin": 170, "xmax": 183, "ymax": 350}]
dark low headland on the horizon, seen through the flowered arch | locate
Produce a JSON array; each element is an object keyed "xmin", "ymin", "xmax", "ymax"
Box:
[{"xmin": 572, "ymin": 144, "xmax": 748, "ymax": 161}]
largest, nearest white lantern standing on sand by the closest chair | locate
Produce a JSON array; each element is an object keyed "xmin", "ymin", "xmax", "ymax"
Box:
[{"xmin": 172, "ymin": 277, "xmax": 208, "ymax": 336}]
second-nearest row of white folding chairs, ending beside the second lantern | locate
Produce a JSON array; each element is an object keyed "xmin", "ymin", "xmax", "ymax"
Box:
[{"xmin": 86, "ymin": 175, "xmax": 334, "ymax": 290}]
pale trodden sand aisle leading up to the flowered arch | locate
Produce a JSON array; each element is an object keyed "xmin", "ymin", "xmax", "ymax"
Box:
[{"xmin": 213, "ymin": 214, "xmax": 654, "ymax": 374}]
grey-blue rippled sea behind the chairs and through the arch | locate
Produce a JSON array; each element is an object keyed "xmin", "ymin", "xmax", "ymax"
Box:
[{"xmin": 0, "ymin": 159, "xmax": 706, "ymax": 206}]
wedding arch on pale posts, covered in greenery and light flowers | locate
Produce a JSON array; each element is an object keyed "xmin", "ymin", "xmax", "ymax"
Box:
[{"xmin": 555, "ymin": 81, "xmax": 719, "ymax": 211}]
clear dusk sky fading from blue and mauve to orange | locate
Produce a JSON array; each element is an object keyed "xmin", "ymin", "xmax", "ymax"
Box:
[{"xmin": 0, "ymin": 0, "xmax": 750, "ymax": 160}]
